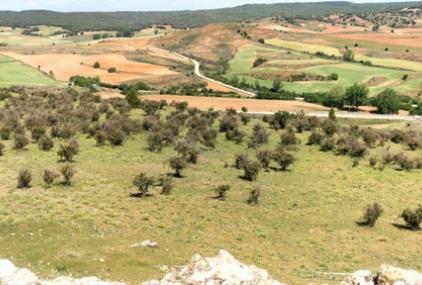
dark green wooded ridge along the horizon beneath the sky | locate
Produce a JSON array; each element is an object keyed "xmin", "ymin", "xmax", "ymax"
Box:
[{"xmin": 0, "ymin": 1, "xmax": 422, "ymax": 31}]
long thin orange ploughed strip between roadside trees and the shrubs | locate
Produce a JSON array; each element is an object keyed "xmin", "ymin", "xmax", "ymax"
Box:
[{"xmin": 142, "ymin": 95, "xmax": 328, "ymax": 112}]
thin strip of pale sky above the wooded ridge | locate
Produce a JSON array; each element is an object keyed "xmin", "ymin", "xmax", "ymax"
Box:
[{"xmin": 0, "ymin": 0, "xmax": 416, "ymax": 12}]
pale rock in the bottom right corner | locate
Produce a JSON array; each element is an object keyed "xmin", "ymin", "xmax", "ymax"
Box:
[{"xmin": 342, "ymin": 265, "xmax": 422, "ymax": 285}]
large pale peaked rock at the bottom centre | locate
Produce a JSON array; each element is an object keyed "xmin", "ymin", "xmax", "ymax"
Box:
[{"xmin": 141, "ymin": 250, "xmax": 282, "ymax": 285}]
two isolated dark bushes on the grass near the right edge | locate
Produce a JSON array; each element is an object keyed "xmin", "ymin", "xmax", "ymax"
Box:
[{"xmin": 357, "ymin": 203, "xmax": 422, "ymax": 231}]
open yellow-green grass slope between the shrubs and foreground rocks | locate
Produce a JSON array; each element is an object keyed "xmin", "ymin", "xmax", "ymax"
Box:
[{"xmin": 0, "ymin": 109, "xmax": 422, "ymax": 284}]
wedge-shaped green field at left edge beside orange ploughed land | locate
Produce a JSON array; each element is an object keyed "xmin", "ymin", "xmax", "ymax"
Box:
[{"xmin": 0, "ymin": 56, "xmax": 63, "ymax": 87}]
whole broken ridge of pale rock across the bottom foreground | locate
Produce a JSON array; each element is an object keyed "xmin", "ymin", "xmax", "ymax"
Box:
[{"xmin": 0, "ymin": 250, "xmax": 422, "ymax": 285}]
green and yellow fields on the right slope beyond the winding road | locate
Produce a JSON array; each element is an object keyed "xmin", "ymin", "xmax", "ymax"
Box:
[{"xmin": 225, "ymin": 40, "xmax": 422, "ymax": 96}]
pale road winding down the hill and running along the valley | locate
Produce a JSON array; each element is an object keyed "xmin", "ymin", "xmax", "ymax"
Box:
[{"xmin": 172, "ymin": 52, "xmax": 422, "ymax": 121}]
